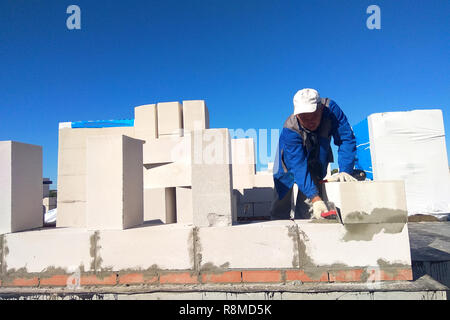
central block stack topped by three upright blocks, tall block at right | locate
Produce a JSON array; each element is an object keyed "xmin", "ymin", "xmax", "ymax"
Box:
[{"xmin": 135, "ymin": 100, "xmax": 234, "ymax": 226}]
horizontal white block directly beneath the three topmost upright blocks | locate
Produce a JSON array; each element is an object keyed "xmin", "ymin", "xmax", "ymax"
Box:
[{"xmin": 144, "ymin": 135, "xmax": 191, "ymax": 164}]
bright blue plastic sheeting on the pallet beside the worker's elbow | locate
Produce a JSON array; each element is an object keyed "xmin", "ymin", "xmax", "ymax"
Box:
[{"xmin": 353, "ymin": 119, "xmax": 373, "ymax": 180}]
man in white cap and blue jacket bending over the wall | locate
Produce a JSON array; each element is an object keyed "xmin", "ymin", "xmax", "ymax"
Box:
[{"xmin": 271, "ymin": 89, "xmax": 356, "ymax": 219}]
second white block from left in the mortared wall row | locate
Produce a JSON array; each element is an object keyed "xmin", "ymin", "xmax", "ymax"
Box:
[{"xmin": 98, "ymin": 224, "xmax": 194, "ymax": 271}]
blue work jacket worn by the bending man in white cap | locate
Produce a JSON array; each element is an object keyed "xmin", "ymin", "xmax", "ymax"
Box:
[{"xmin": 274, "ymin": 98, "xmax": 356, "ymax": 199}]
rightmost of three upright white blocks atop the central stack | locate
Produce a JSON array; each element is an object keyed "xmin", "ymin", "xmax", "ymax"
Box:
[{"xmin": 183, "ymin": 100, "xmax": 209, "ymax": 131}]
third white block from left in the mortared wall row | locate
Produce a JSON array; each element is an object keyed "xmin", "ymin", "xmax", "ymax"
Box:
[{"xmin": 198, "ymin": 220, "xmax": 298, "ymax": 269}]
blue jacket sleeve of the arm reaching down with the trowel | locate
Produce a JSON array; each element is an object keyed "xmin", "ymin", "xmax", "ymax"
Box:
[{"xmin": 281, "ymin": 128, "xmax": 319, "ymax": 199}]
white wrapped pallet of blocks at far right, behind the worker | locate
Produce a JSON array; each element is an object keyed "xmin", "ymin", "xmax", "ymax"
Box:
[{"xmin": 368, "ymin": 110, "xmax": 450, "ymax": 215}]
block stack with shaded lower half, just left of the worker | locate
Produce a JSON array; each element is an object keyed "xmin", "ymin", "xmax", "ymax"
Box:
[{"xmin": 232, "ymin": 138, "xmax": 274, "ymax": 219}]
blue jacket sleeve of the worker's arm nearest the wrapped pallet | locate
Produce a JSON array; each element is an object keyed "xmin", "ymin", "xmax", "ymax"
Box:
[{"xmin": 329, "ymin": 100, "xmax": 356, "ymax": 174}]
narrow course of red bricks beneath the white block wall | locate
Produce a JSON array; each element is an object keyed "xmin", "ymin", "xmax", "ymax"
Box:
[{"xmin": 0, "ymin": 269, "xmax": 412, "ymax": 287}]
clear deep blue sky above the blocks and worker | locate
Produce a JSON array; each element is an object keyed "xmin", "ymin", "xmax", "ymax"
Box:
[{"xmin": 0, "ymin": 0, "xmax": 450, "ymax": 187}]
